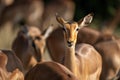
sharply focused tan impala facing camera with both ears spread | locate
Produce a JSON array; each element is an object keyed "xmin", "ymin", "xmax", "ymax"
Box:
[{"xmin": 56, "ymin": 14, "xmax": 102, "ymax": 80}]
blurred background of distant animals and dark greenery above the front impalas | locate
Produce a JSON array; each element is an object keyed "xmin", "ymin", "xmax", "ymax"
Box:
[{"xmin": 0, "ymin": 0, "xmax": 120, "ymax": 49}]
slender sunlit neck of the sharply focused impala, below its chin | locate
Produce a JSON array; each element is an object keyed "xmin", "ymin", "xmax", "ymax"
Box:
[{"xmin": 64, "ymin": 46, "xmax": 77, "ymax": 75}]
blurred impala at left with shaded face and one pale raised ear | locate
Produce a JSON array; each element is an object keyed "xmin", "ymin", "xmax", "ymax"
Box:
[{"xmin": 12, "ymin": 26, "xmax": 54, "ymax": 72}]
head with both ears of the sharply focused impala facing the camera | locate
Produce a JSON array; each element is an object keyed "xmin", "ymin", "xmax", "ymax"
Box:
[{"xmin": 56, "ymin": 14, "xmax": 93, "ymax": 47}]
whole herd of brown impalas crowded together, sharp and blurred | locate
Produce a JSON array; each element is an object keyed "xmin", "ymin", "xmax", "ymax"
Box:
[{"xmin": 0, "ymin": 0, "xmax": 120, "ymax": 80}]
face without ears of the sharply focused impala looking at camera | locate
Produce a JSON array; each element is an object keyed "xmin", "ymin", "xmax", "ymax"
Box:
[{"xmin": 63, "ymin": 22, "xmax": 79, "ymax": 47}]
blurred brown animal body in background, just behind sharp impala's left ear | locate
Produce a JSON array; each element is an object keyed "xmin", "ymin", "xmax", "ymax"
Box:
[{"xmin": 40, "ymin": 0, "xmax": 75, "ymax": 31}]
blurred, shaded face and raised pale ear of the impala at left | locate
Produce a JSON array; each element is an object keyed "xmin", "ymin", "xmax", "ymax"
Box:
[{"xmin": 33, "ymin": 25, "xmax": 54, "ymax": 61}]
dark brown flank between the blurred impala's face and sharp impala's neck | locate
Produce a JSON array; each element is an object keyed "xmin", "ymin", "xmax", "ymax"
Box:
[{"xmin": 46, "ymin": 28, "xmax": 66, "ymax": 63}]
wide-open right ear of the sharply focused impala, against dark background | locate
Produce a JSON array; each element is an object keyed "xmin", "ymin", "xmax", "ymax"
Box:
[{"xmin": 78, "ymin": 13, "xmax": 94, "ymax": 27}]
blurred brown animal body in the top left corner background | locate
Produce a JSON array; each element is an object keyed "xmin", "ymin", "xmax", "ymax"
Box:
[{"xmin": 0, "ymin": 0, "xmax": 44, "ymax": 26}]
